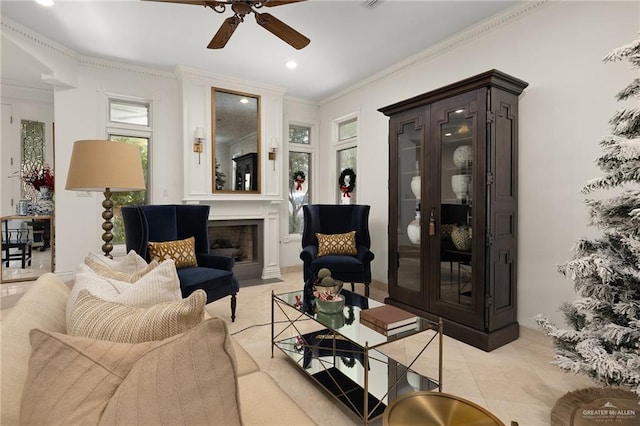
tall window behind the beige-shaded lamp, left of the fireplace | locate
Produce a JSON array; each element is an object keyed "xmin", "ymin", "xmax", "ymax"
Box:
[{"xmin": 107, "ymin": 99, "xmax": 151, "ymax": 245}]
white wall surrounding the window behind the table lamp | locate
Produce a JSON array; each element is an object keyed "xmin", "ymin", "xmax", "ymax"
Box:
[{"xmin": 55, "ymin": 65, "xmax": 183, "ymax": 274}]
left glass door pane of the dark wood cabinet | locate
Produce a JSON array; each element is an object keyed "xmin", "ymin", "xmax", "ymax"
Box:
[{"xmin": 396, "ymin": 116, "xmax": 425, "ymax": 293}]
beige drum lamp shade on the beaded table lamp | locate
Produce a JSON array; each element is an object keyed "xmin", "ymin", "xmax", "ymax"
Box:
[{"xmin": 65, "ymin": 140, "xmax": 145, "ymax": 192}]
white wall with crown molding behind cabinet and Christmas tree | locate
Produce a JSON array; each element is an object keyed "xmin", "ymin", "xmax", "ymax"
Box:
[{"xmin": 320, "ymin": 2, "xmax": 640, "ymax": 326}]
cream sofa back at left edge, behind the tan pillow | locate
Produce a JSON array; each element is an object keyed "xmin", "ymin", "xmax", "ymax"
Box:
[{"xmin": 0, "ymin": 273, "xmax": 69, "ymax": 425}]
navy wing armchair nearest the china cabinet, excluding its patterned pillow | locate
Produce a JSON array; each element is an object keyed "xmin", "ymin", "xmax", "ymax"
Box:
[{"xmin": 300, "ymin": 204, "xmax": 374, "ymax": 296}]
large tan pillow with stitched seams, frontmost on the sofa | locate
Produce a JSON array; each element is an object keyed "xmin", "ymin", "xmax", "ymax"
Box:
[{"xmin": 20, "ymin": 318, "xmax": 242, "ymax": 425}]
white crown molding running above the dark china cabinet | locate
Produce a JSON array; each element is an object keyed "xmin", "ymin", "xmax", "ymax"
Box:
[{"xmin": 318, "ymin": 0, "xmax": 551, "ymax": 105}]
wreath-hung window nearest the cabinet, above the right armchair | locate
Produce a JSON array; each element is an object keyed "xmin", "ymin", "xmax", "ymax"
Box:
[{"xmin": 334, "ymin": 114, "xmax": 358, "ymax": 204}]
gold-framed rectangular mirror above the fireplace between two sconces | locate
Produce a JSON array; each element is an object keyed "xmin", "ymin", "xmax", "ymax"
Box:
[{"xmin": 211, "ymin": 87, "xmax": 260, "ymax": 194}]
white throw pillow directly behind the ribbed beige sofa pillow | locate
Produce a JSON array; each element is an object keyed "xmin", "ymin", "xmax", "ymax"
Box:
[{"xmin": 66, "ymin": 260, "xmax": 182, "ymax": 325}]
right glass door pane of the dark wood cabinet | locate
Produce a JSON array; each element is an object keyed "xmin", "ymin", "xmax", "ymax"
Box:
[{"xmin": 438, "ymin": 105, "xmax": 476, "ymax": 306}]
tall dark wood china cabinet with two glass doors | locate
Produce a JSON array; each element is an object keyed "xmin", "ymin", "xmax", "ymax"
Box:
[{"xmin": 379, "ymin": 70, "xmax": 528, "ymax": 351}]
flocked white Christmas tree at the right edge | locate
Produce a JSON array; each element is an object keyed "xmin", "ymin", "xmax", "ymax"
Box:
[{"xmin": 536, "ymin": 39, "xmax": 640, "ymax": 395}]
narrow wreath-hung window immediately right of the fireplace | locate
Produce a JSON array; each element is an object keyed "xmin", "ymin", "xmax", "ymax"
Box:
[{"xmin": 289, "ymin": 125, "xmax": 313, "ymax": 234}]
